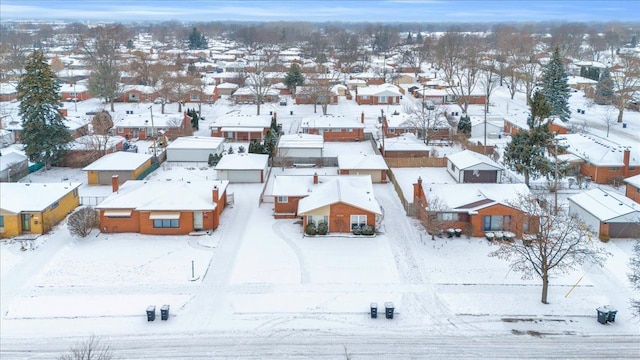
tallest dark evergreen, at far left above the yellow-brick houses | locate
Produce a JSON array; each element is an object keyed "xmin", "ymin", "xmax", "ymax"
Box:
[{"xmin": 17, "ymin": 51, "xmax": 72, "ymax": 167}]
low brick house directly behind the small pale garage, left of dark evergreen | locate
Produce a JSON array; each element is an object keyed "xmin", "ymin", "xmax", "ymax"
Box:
[{"xmin": 209, "ymin": 114, "xmax": 275, "ymax": 142}]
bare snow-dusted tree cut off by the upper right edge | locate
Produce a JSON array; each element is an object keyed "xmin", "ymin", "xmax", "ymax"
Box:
[{"xmin": 611, "ymin": 54, "xmax": 640, "ymax": 123}]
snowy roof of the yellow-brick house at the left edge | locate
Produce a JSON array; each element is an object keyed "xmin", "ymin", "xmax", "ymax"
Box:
[{"xmin": 0, "ymin": 182, "xmax": 82, "ymax": 214}]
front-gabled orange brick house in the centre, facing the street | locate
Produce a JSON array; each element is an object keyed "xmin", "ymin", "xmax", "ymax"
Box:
[{"xmin": 298, "ymin": 175, "xmax": 382, "ymax": 233}]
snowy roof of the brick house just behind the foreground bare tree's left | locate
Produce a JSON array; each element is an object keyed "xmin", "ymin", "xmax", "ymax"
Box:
[{"xmin": 422, "ymin": 182, "xmax": 530, "ymax": 212}]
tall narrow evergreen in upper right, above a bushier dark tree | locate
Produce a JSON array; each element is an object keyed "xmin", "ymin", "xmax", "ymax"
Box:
[{"xmin": 542, "ymin": 47, "xmax": 571, "ymax": 121}]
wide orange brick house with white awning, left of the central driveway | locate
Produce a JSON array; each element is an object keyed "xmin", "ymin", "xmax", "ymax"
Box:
[{"xmin": 97, "ymin": 176, "xmax": 229, "ymax": 235}]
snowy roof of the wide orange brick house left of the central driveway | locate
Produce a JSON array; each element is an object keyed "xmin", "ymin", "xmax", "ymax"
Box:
[{"xmin": 97, "ymin": 180, "xmax": 229, "ymax": 211}]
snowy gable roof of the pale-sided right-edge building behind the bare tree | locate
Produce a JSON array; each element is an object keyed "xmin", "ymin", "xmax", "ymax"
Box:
[{"xmin": 568, "ymin": 188, "xmax": 640, "ymax": 222}]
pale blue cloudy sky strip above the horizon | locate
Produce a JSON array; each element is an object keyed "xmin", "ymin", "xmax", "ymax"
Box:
[{"xmin": 0, "ymin": 0, "xmax": 640, "ymax": 22}]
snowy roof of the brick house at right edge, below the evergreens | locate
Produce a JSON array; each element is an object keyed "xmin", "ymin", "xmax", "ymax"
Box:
[{"xmin": 559, "ymin": 134, "xmax": 640, "ymax": 166}]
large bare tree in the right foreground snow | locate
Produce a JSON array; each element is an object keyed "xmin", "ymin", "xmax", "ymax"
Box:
[{"xmin": 489, "ymin": 195, "xmax": 610, "ymax": 304}]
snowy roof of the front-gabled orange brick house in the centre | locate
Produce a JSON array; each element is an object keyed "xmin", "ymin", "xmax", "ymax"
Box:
[{"xmin": 298, "ymin": 175, "xmax": 382, "ymax": 215}]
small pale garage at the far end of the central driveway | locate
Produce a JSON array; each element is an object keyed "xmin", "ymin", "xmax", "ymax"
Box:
[{"xmin": 215, "ymin": 153, "xmax": 269, "ymax": 183}]
